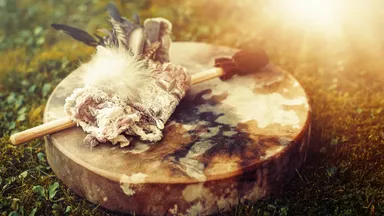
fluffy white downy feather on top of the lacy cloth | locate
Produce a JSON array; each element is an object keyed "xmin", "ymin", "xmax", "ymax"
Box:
[{"xmin": 84, "ymin": 46, "xmax": 152, "ymax": 102}]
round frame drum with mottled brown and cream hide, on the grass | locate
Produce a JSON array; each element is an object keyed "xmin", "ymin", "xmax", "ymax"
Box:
[{"xmin": 44, "ymin": 42, "xmax": 310, "ymax": 215}]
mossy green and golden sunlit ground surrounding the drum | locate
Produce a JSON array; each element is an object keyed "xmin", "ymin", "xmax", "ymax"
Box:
[{"xmin": 0, "ymin": 0, "xmax": 384, "ymax": 215}]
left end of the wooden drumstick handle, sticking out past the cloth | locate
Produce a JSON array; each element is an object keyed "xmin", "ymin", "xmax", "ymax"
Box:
[{"xmin": 10, "ymin": 117, "xmax": 76, "ymax": 145}]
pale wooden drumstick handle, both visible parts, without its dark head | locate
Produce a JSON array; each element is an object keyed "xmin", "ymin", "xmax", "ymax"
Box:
[{"xmin": 10, "ymin": 67, "xmax": 224, "ymax": 145}]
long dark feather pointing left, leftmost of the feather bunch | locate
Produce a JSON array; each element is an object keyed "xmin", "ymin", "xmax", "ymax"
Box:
[{"xmin": 51, "ymin": 24, "xmax": 99, "ymax": 46}]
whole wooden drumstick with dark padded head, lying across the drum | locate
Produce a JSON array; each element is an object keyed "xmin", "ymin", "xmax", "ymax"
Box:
[{"xmin": 10, "ymin": 50, "xmax": 269, "ymax": 145}]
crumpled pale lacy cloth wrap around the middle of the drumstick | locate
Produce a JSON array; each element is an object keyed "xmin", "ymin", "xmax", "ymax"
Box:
[{"xmin": 64, "ymin": 60, "xmax": 191, "ymax": 147}]
